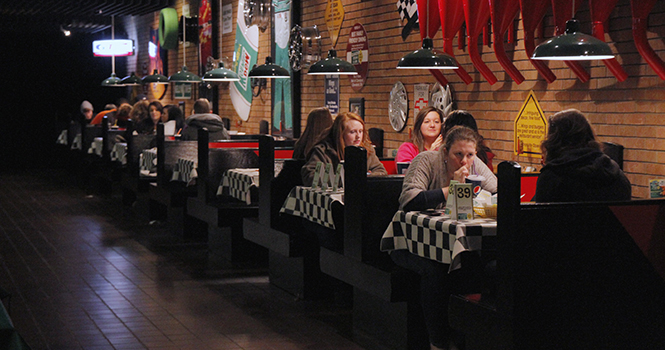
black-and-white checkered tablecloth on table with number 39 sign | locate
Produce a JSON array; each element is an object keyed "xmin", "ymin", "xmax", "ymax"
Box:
[{"xmin": 381, "ymin": 211, "xmax": 496, "ymax": 270}]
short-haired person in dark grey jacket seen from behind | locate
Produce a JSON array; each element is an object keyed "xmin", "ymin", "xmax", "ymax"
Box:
[{"xmin": 181, "ymin": 98, "xmax": 231, "ymax": 141}]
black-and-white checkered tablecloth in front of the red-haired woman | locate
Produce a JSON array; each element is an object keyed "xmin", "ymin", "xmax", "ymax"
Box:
[{"xmin": 279, "ymin": 186, "xmax": 344, "ymax": 229}]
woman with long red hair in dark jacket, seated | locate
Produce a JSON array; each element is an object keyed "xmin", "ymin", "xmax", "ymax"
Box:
[{"xmin": 300, "ymin": 112, "xmax": 388, "ymax": 186}]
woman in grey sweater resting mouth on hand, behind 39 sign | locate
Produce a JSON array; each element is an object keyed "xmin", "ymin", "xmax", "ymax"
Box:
[{"xmin": 399, "ymin": 126, "xmax": 497, "ymax": 211}]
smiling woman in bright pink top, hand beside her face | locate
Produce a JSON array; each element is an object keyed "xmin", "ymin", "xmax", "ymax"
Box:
[{"xmin": 395, "ymin": 106, "xmax": 443, "ymax": 162}]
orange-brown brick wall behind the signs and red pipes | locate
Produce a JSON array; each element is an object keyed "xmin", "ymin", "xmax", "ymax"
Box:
[{"xmin": 122, "ymin": 0, "xmax": 665, "ymax": 198}]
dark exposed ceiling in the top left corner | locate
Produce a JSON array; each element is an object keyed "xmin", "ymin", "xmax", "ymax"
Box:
[{"xmin": 0, "ymin": 0, "xmax": 175, "ymax": 33}]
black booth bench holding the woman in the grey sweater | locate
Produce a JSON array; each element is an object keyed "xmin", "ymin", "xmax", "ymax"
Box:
[{"xmin": 312, "ymin": 147, "xmax": 429, "ymax": 349}]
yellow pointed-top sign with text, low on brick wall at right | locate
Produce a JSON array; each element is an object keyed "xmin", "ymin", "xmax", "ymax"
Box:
[{"xmin": 514, "ymin": 91, "xmax": 547, "ymax": 157}]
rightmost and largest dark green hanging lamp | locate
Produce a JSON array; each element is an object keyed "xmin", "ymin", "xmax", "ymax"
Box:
[{"xmin": 531, "ymin": 0, "xmax": 614, "ymax": 61}]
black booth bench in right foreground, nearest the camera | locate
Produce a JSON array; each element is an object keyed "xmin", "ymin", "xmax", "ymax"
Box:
[{"xmin": 449, "ymin": 162, "xmax": 665, "ymax": 350}]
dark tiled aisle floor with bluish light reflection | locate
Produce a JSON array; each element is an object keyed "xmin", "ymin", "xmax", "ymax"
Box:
[{"xmin": 0, "ymin": 171, "xmax": 361, "ymax": 350}]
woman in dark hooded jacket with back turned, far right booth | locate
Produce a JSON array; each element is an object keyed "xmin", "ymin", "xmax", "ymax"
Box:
[{"xmin": 535, "ymin": 109, "xmax": 631, "ymax": 202}]
